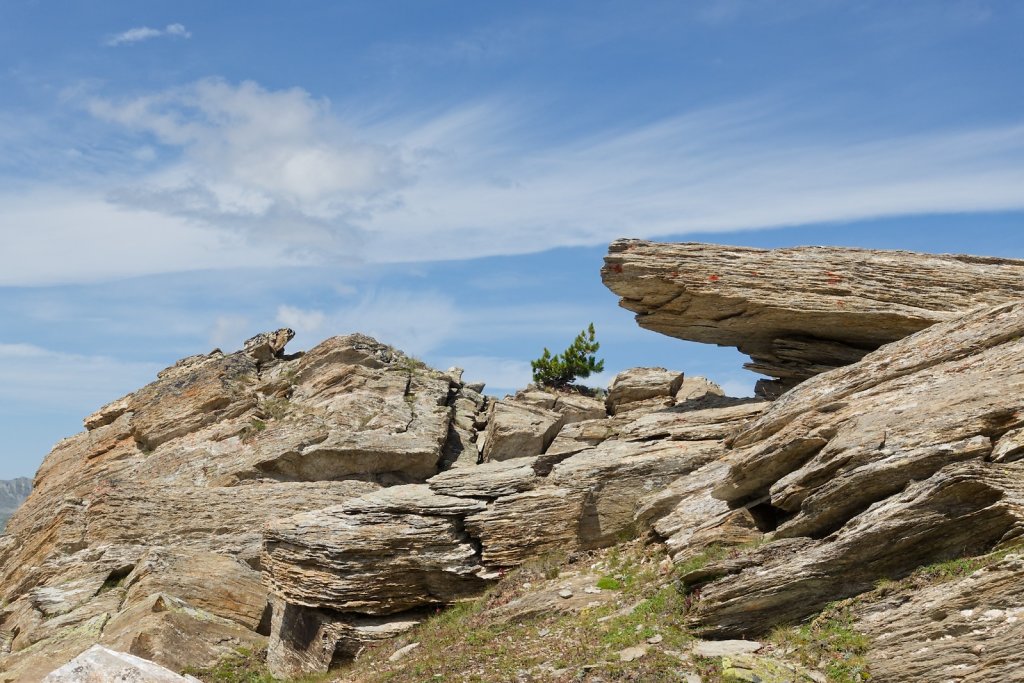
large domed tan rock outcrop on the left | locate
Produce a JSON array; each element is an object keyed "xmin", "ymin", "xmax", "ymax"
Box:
[{"xmin": 0, "ymin": 330, "xmax": 484, "ymax": 681}]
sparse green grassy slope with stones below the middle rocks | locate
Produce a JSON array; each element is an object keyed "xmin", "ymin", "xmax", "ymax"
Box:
[{"xmin": 335, "ymin": 544, "xmax": 704, "ymax": 683}]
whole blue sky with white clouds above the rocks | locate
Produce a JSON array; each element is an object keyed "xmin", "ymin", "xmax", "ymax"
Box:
[{"xmin": 0, "ymin": 0, "xmax": 1024, "ymax": 478}]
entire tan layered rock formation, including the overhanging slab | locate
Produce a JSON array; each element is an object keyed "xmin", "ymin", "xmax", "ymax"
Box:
[{"xmin": 8, "ymin": 241, "xmax": 1024, "ymax": 681}]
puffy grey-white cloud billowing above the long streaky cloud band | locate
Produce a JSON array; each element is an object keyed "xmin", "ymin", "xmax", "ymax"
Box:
[{"xmin": 87, "ymin": 79, "xmax": 406, "ymax": 254}]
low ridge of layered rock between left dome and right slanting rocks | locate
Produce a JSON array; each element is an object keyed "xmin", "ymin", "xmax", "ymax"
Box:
[{"xmin": 261, "ymin": 378, "xmax": 764, "ymax": 676}]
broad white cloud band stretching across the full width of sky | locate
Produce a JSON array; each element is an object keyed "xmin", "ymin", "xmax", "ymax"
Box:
[{"xmin": 0, "ymin": 80, "xmax": 1024, "ymax": 284}]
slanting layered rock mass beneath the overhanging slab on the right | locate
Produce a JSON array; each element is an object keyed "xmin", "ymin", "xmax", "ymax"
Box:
[{"xmin": 679, "ymin": 302, "xmax": 1024, "ymax": 636}]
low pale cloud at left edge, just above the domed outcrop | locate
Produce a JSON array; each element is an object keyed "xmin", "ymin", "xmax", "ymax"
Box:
[{"xmin": 0, "ymin": 343, "xmax": 161, "ymax": 409}]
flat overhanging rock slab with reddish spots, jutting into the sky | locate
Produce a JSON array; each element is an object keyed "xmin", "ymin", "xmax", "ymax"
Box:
[{"xmin": 601, "ymin": 240, "xmax": 1024, "ymax": 397}]
